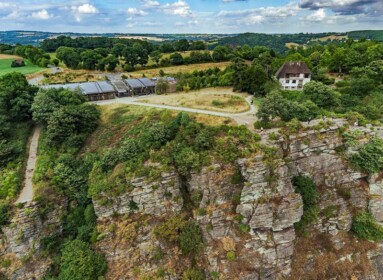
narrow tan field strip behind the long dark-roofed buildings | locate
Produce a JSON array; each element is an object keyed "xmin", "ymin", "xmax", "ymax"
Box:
[{"xmin": 129, "ymin": 62, "xmax": 230, "ymax": 78}]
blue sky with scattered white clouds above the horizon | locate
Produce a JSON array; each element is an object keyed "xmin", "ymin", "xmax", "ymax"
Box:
[{"xmin": 0, "ymin": 0, "xmax": 383, "ymax": 34}]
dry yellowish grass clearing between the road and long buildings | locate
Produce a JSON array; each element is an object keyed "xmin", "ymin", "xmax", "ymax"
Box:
[{"xmin": 140, "ymin": 88, "xmax": 250, "ymax": 113}]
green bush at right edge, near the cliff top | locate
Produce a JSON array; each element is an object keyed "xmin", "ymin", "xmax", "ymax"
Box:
[{"xmin": 350, "ymin": 138, "xmax": 383, "ymax": 174}]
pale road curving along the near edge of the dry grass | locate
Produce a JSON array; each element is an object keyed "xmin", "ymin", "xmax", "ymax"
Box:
[{"xmin": 94, "ymin": 95, "xmax": 257, "ymax": 129}]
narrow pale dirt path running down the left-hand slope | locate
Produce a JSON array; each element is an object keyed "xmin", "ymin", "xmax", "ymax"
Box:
[{"xmin": 16, "ymin": 127, "xmax": 41, "ymax": 203}]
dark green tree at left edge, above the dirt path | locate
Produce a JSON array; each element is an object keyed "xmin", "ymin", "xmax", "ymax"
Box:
[{"xmin": 0, "ymin": 72, "xmax": 38, "ymax": 121}]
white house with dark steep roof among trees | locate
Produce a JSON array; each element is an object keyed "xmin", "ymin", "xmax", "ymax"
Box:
[{"xmin": 275, "ymin": 61, "xmax": 312, "ymax": 90}]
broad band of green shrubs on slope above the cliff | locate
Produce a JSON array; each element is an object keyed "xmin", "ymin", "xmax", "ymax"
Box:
[{"xmin": 89, "ymin": 107, "xmax": 259, "ymax": 201}]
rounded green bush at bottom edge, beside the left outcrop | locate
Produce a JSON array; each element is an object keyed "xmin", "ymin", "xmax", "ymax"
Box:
[{"xmin": 58, "ymin": 240, "xmax": 106, "ymax": 280}]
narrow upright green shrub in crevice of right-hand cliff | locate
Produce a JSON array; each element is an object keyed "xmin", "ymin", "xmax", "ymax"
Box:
[{"xmin": 293, "ymin": 175, "xmax": 319, "ymax": 234}]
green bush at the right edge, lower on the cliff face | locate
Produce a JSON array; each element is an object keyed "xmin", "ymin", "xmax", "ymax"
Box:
[{"xmin": 351, "ymin": 212, "xmax": 383, "ymax": 241}]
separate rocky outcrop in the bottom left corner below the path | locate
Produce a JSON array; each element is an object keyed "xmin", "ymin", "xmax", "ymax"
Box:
[{"xmin": 0, "ymin": 201, "xmax": 66, "ymax": 279}]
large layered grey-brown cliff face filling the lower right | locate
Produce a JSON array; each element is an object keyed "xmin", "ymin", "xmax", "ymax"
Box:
[{"xmin": 91, "ymin": 123, "xmax": 383, "ymax": 279}]
